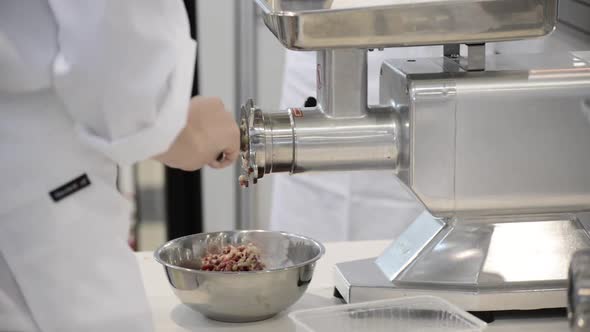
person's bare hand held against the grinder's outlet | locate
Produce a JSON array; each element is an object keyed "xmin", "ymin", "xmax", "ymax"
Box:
[{"xmin": 155, "ymin": 96, "xmax": 240, "ymax": 171}]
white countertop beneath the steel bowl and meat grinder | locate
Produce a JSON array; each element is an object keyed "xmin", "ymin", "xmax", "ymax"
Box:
[{"xmin": 137, "ymin": 241, "xmax": 569, "ymax": 332}]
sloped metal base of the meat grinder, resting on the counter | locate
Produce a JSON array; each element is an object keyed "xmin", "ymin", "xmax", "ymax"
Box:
[{"xmin": 334, "ymin": 219, "xmax": 590, "ymax": 311}]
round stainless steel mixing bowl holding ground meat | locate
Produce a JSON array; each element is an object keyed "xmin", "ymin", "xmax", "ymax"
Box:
[{"xmin": 154, "ymin": 231, "xmax": 325, "ymax": 322}]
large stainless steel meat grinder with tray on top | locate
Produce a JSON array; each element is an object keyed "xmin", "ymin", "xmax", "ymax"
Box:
[{"xmin": 241, "ymin": 0, "xmax": 590, "ymax": 311}]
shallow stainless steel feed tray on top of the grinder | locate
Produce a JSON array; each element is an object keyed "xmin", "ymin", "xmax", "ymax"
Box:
[{"xmin": 256, "ymin": 0, "xmax": 557, "ymax": 50}]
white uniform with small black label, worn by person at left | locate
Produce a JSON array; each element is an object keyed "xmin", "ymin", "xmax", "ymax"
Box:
[{"xmin": 0, "ymin": 0, "xmax": 196, "ymax": 332}]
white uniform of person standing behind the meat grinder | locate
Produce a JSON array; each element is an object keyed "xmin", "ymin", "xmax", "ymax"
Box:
[{"xmin": 271, "ymin": 40, "xmax": 543, "ymax": 241}]
